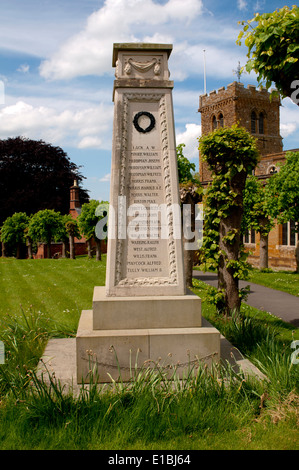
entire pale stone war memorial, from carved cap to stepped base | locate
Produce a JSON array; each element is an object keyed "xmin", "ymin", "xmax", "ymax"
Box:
[{"xmin": 76, "ymin": 43, "xmax": 220, "ymax": 382}]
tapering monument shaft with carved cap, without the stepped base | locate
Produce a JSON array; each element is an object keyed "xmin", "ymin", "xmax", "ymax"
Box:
[{"xmin": 106, "ymin": 44, "xmax": 185, "ymax": 297}]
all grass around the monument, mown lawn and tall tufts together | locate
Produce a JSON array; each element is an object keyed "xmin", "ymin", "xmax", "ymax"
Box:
[{"xmin": 0, "ymin": 256, "xmax": 299, "ymax": 450}]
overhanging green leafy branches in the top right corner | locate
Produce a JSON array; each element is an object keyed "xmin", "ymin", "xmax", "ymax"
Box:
[{"xmin": 237, "ymin": 5, "xmax": 299, "ymax": 105}]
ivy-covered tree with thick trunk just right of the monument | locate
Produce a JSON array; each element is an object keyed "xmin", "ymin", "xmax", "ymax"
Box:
[{"xmin": 199, "ymin": 125, "xmax": 259, "ymax": 315}]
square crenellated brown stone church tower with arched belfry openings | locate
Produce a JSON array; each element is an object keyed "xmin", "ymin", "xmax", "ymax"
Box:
[{"xmin": 198, "ymin": 82, "xmax": 282, "ymax": 184}]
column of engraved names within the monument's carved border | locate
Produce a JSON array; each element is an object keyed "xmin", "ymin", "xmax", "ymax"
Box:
[{"xmin": 126, "ymin": 103, "xmax": 169, "ymax": 278}]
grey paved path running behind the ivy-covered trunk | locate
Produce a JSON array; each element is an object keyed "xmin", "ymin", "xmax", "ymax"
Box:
[{"xmin": 193, "ymin": 271, "xmax": 299, "ymax": 328}]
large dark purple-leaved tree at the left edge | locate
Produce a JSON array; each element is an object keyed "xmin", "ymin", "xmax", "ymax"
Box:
[{"xmin": 0, "ymin": 137, "xmax": 88, "ymax": 223}]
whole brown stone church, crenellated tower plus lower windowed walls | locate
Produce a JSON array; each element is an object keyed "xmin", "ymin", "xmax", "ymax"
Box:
[{"xmin": 198, "ymin": 82, "xmax": 298, "ymax": 269}]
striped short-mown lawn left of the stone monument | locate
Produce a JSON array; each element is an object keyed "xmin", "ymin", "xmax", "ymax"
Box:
[{"xmin": 0, "ymin": 255, "xmax": 106, "ymax": 334}]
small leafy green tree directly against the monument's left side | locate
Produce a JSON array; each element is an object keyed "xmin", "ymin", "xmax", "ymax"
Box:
[{"xmin": 78, "ymin": 199, "xmax": 108, "ymax": 261}]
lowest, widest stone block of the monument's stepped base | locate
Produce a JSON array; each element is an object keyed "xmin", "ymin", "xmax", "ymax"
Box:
[{"xmin": 76, "ymin": 310, "xmax": 220, "ymax": 383}]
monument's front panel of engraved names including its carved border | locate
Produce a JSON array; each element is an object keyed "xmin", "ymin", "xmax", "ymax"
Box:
[{"xmin": 116, "ymin": 93, "xmax": 178, "ymax": 286}]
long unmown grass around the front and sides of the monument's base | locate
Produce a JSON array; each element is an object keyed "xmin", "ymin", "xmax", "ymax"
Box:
[{"xmin": 0, "ymin": 258, "xmax": 298, "ymax": 449}]
